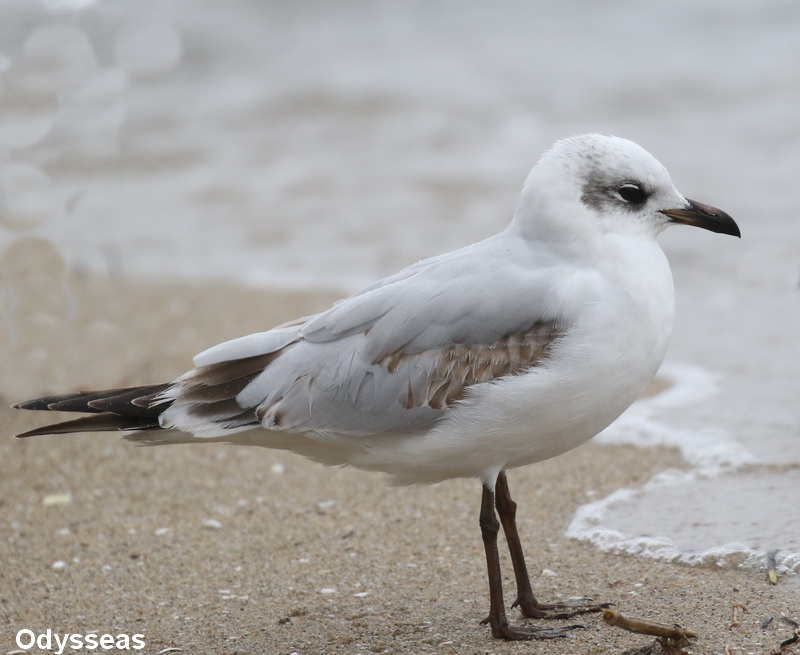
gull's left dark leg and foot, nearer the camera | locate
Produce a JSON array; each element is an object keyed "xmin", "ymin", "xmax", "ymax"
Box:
[{"xmin": 480, "ymin": 485, "xmax": 581, "ymax": 641}]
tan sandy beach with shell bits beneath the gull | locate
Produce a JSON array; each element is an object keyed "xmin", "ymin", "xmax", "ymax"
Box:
[{"xmin": 0, "ymin": 267, "xmax": 800, "ymax": 655}]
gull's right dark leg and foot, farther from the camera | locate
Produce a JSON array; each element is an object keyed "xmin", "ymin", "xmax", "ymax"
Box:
[{"xmin": 494, "ymin": 471, "xmax": 602, "ymax": 619}]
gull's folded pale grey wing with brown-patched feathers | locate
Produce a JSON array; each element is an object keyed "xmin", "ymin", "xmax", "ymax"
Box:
[{"xmin": 164, "ymin": 233, "xmax": 588, "ymax": 436}]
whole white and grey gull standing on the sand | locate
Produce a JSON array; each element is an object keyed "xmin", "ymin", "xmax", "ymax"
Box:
[{"xmin": 15, "ymin": 134, "xmax": 740, "ymax": 640}]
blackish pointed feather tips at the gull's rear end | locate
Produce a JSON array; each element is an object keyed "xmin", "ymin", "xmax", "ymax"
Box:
[{"xmin": 14, "ymin": 383, "xmax": 172, "ymax": 438}]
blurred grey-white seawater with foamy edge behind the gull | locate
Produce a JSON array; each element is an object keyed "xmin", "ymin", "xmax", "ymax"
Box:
[{"xmin": 0, "ymin": 0, "xmax": 800, "ymax": 570}]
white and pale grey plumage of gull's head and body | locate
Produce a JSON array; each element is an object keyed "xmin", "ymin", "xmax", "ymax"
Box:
[{"xmin": 139, "ymin": 135, "xmax": 732, "ymax": 484}]
